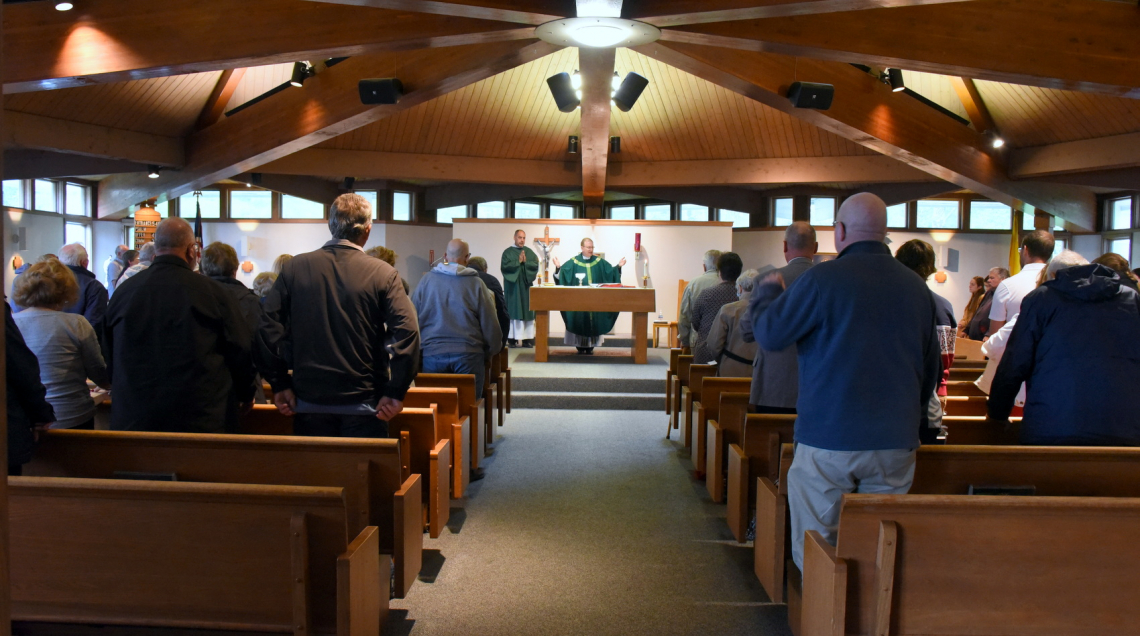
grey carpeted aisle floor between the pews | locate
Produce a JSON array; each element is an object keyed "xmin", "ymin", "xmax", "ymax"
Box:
[{"xmin": 384, "ymin": 409, "xmax": 789, "ymax": 636}]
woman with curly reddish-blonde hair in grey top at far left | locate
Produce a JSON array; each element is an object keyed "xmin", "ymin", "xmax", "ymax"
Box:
[{"xmin": 14, "ymin": 260, "xmax": 111, "ymax": 429}]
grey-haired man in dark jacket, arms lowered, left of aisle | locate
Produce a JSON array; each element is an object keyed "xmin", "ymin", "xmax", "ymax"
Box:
[{"xmin": 259, "ymin": 194, "xmax": 420, "ymax": 438}]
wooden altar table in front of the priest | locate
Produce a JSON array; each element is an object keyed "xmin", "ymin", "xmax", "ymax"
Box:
[{"xmin": 530, "ymin": 286, "xmax": 657, "ymax": 365}]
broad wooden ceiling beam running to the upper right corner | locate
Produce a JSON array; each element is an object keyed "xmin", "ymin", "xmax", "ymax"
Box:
[{"xmin": 661, "ymin": 0, "xmax": 1140, "ymax": 98}]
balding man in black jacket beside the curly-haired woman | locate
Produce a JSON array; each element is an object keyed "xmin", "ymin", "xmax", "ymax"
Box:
[{"xmin": 104, "ymin": 218, "xmax": 253, "ymax": 433}]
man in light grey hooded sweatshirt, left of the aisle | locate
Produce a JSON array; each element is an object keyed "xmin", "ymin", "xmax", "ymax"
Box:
[{"xmin": 412, "ymin": 238, "xmax": 503, "ymax": 386}]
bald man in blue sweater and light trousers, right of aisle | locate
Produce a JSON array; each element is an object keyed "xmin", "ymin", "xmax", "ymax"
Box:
[{"xmin": 750, "ymin": 193, "xmax": 942, "ymax": 569}]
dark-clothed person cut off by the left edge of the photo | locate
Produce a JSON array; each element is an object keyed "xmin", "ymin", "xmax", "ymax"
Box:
[{"xmin": 3, "ymin": 303, "xmax": 56, "ymax": 475}]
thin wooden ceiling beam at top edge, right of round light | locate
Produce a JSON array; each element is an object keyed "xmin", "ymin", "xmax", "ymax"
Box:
[{"xmin": 628, "ymin": 0, "xmax": 974, "ymax": 28}]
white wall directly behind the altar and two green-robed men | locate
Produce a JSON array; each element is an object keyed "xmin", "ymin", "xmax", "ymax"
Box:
[{"xmin": 449, "ymin": 219, "xmax": 732, "ymax": 337}]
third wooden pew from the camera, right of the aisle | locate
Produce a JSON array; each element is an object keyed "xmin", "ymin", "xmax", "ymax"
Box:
[{"xmin": 725, "ymin": 414, "xmax": 796, "ymax": 543}]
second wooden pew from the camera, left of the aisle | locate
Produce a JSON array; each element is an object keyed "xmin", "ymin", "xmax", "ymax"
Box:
[{"xmin": 24, "ymin": 429, "xmax": 423, "ymax": 598}]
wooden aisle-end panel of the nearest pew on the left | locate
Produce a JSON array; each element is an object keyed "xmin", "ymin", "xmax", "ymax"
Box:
[{"xmin": 336, "ymin": 525, "xmax": 392, "ymax": 636}]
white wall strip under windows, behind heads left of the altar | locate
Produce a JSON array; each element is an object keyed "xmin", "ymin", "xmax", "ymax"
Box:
[{"xmin": 202, "ymin": 221, "xmax": 451, "ymax": 288}]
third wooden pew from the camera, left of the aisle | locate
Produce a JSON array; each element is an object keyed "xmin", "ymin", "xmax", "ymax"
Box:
[{"xmin": 238, "ymin": 403, "xmax": 446, "ymax": 539}]
